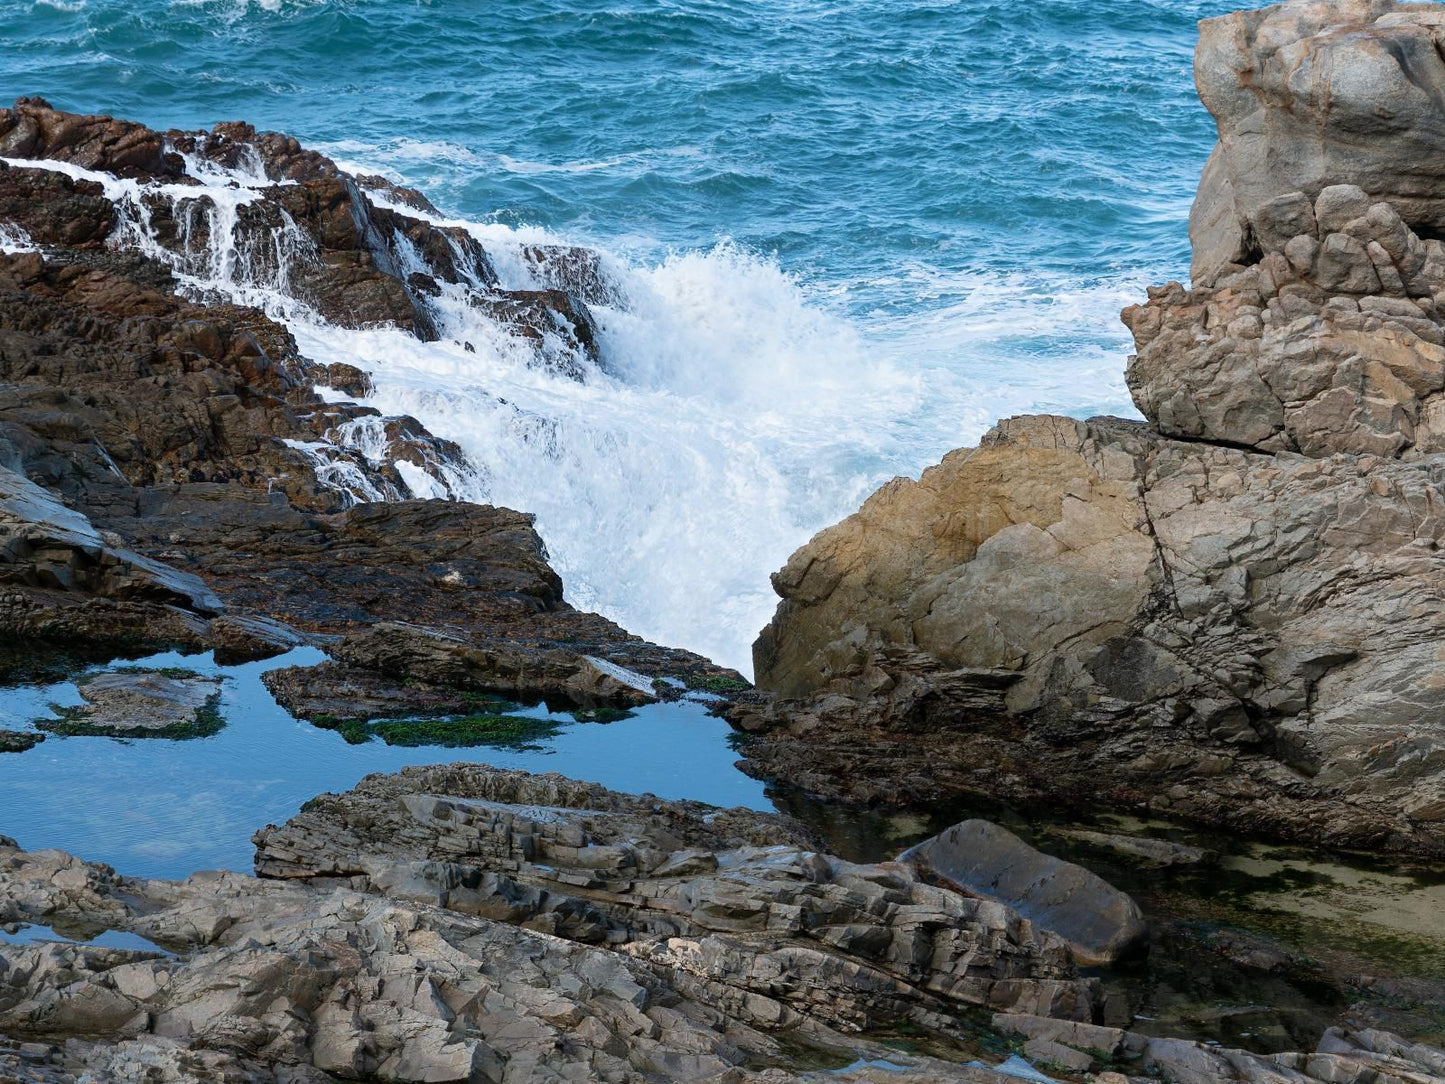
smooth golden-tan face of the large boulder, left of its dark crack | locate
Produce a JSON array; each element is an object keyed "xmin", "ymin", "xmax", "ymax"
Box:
[{"xmin": 754, "ymin": 419, "xmax": 1153, "ymax": 701}]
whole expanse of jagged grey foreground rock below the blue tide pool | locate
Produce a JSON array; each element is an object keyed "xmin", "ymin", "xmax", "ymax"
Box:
[{"xmin": 0, "ymin": 765, "xmax": 1442, "ymax": 1084}]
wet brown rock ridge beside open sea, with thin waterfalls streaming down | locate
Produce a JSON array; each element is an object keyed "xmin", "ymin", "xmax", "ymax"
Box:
[{"xmin": 0, "ymin": 98, "xmax": 617, "ymax": 380}]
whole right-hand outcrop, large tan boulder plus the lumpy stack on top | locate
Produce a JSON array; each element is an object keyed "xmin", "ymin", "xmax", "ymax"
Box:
[{"xmin": 734, "ymin": 0, "xmax": 1445, "ymax": 854}]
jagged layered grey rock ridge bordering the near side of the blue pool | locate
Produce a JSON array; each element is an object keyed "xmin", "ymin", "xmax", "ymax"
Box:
[{"xmin": 256, "ymin": 765, "xmax": 1097, "ymax": 1029}]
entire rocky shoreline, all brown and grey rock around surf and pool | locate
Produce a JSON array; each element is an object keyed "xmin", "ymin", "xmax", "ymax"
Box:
[{"xmin": 8, "ymin": 0, "xmax": 1445, "ymax": 1084}]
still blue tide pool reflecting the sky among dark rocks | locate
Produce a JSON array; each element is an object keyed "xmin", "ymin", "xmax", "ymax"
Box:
[{"xmin": 0, "ymin": 648, "xmax": 773, "ymax": 877}]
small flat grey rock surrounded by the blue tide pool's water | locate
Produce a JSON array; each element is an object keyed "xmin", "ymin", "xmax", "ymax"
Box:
[{"xmin": 38, "ymin": 671, "xmax": 221, "ymax": 737}]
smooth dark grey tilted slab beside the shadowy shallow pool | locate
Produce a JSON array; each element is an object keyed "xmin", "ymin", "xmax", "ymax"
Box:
[{"xmin": 899, "ymin": 820, "xmax": 1146, "ymax": 965}]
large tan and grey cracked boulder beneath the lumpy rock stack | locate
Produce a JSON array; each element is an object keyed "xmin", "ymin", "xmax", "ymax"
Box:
[{"xmin": 733, "ymin": 418, "xmax": 1445, "ymax": 853}]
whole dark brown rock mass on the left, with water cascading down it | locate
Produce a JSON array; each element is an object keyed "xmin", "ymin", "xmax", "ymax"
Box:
[{"xmin": 0, "ymin": 98, "xmax": 736, "ymax": 714}]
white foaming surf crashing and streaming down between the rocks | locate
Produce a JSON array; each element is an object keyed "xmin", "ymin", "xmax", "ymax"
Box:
[{"xmin": 0, "ymin": 151, "xmax": 1133, "ymax": 674}]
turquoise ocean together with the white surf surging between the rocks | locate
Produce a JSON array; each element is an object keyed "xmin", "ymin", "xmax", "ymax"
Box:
[{"xmin": 0, "ymin": 0, "xmax": 1238, "ymax": 672}]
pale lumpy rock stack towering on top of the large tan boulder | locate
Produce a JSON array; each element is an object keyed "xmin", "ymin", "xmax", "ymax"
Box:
[{"xmin": 1124, "ymin": 0, "xmax": 1445, "ymax": 457}]
